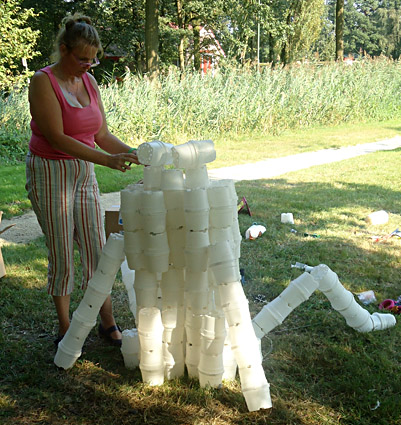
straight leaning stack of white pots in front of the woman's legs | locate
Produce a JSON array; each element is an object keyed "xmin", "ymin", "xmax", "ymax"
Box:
[{"xmin": 54, "ymin": 233, "xmax": 124, "ymax": 369}]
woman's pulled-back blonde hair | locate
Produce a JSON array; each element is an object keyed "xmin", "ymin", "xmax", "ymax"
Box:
[{"xmin": 52, "ymin": 13, "xmax": 103, "ymax": 61}]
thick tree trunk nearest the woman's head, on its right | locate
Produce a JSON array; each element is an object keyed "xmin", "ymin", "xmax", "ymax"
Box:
[{"xmin": 145, "ymin": 0, "xmax": 159, "ymax": 79}]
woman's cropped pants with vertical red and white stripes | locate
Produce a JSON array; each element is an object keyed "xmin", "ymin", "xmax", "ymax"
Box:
[{"xmin": 26, "ymin": 153, "xmax": 105, "ymax": 296}]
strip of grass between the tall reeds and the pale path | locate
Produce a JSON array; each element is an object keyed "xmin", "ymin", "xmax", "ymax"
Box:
[{"xmin": 0, "ymin": 120, "xmax": 401, "ymax": 219}]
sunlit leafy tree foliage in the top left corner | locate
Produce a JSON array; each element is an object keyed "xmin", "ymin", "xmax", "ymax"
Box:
[{"xmin": 0, "ymin": 0, "xmax": 39, "ymax": 93}]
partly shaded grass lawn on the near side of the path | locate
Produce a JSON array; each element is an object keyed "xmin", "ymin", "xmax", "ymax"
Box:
[{"xmin": 0, "ymin": 141, "xmax": 401, "ymax": 425}]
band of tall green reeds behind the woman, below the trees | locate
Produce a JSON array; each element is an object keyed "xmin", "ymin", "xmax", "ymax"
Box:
[{"xmin": 0, "ymin": 59, "xmax": 401, "ymax": 161}]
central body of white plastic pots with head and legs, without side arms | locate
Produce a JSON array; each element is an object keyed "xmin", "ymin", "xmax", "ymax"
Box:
[{"xmin": 121, "ymin": 140, "xmax": 271, "ymax": 410}]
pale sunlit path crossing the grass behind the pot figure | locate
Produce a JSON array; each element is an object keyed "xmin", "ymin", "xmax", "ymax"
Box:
[{"xmin": 0, "ymin": 136, "xmax": 401, "ymax": 246}]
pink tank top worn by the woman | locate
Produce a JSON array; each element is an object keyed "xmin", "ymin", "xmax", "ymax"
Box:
[{"xmin": 29, "ymin": 66, "xmax": 102, "ymax": 159}]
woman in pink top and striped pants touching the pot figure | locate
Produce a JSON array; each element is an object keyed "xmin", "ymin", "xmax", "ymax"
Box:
[{"xmin": 26, "ymin": 14, "xmax": 138, "ymax": 345}]
